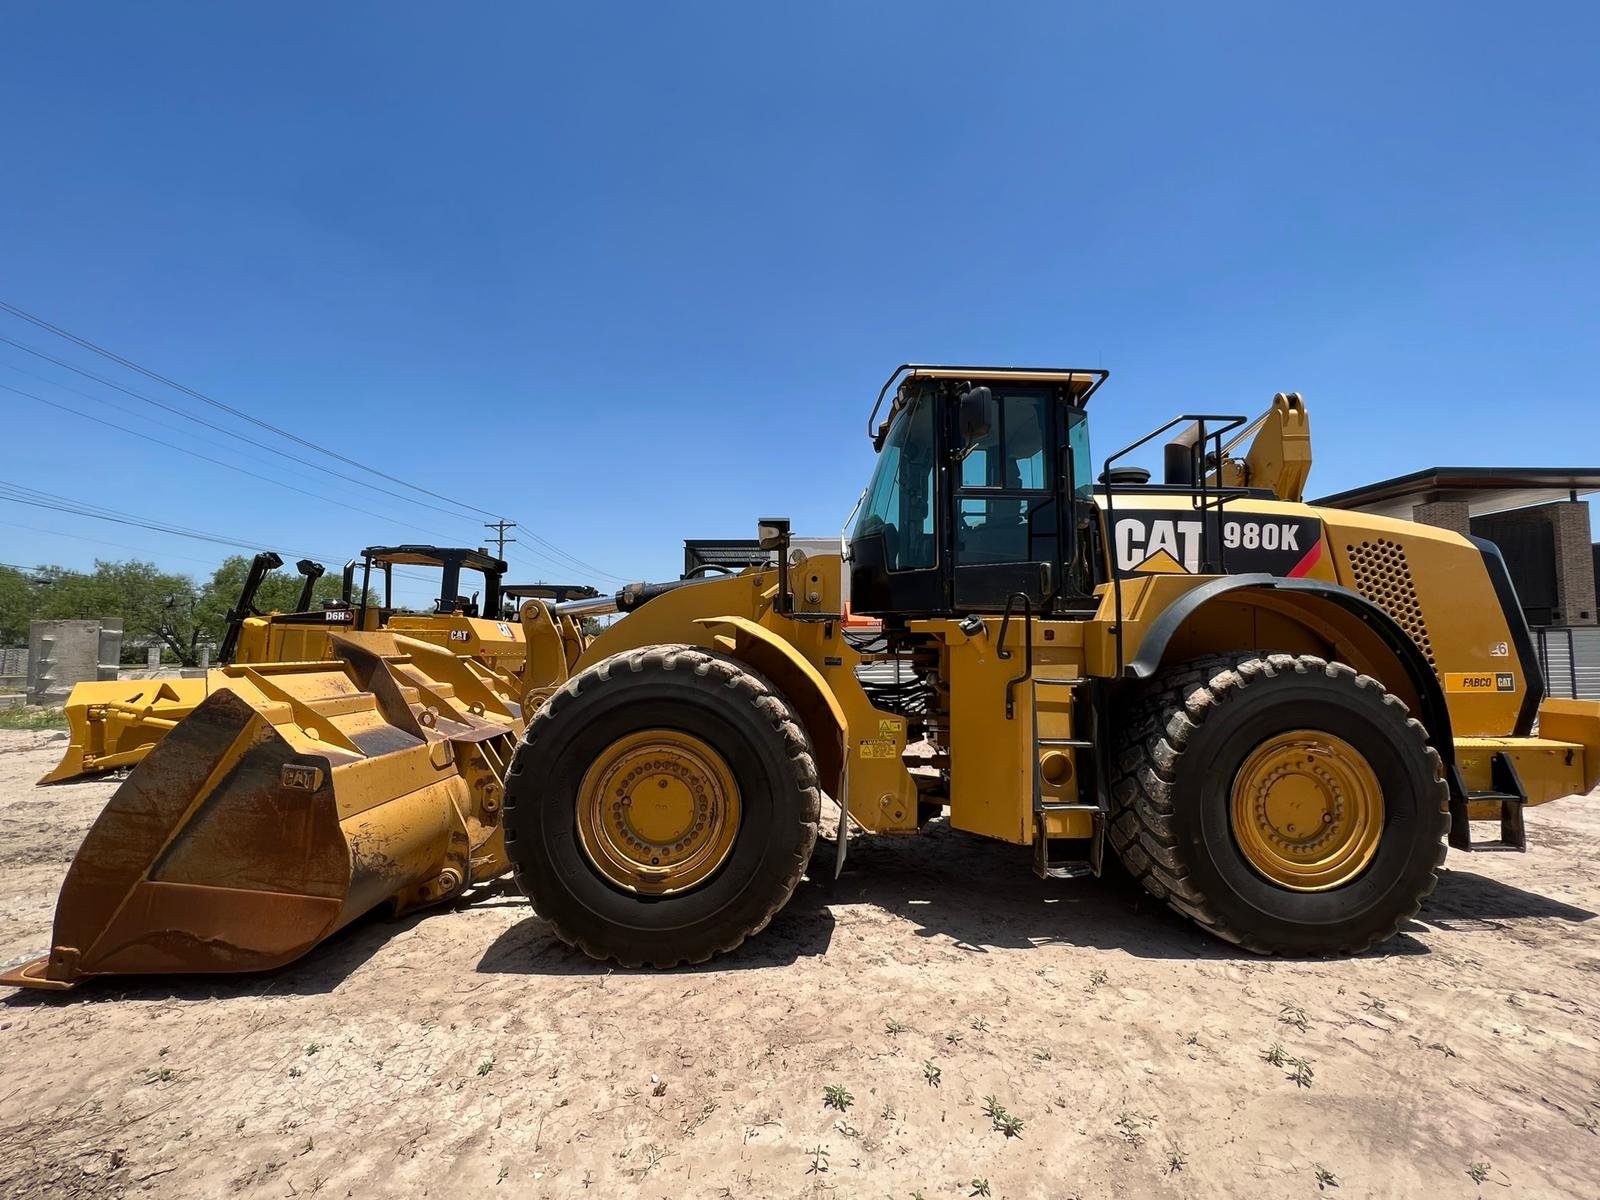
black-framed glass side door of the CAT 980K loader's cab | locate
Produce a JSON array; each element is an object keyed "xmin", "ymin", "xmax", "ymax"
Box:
[{"xmin": 949, "ymin": 386, "xmax": 1072, "ymax": 613}]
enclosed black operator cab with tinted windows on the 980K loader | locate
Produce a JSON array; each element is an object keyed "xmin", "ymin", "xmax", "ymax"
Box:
[{"xmin": 850, "ymin": 365, "xmax": 1107, "ymax": 616}]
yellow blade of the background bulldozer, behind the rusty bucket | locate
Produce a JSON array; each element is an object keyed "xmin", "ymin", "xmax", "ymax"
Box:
[{"xmin": 38, "ymin": 678, "xmax": 210, "ymax": 784}]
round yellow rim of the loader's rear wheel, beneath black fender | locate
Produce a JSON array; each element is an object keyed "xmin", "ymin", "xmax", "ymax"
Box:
[{"xmin": 1232, "ymin": 730, "xmax": 1384, "ymax": 891}]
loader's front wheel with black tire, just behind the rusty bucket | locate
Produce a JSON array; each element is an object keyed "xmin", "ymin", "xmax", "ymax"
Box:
[{"xmin": 506, "ymin": 645, "xmax": 821, "ymax": 968}]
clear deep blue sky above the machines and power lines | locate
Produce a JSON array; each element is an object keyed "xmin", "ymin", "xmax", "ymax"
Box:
[{"xmin": 0, "ymin": 3, "xmax": 1600, "ymax": 601}]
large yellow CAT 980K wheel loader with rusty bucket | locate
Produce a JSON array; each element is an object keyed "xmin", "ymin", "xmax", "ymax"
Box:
[{"xmin": 5, "ymin": 365, "xmax": 1600, "ymax": 987}]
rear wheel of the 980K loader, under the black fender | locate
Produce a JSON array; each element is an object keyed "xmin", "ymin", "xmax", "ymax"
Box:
[{"xmin": 1109, "ymin": 654, "xmax": 1450, "ymax": 954}]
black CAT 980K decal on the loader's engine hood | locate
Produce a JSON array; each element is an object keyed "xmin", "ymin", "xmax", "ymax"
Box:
[{"xmin": 1112, "ymin": 509, "xmax": 1322, "ymax": 578}]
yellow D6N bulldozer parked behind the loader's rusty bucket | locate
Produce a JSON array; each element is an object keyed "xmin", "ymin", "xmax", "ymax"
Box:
[{"xmin": 40, "ymin": 546, "xmax": 598, "ymax": 784}]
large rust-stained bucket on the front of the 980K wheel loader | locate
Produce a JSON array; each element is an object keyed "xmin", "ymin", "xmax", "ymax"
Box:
[{"xmin": 0, "ymin": 634, "xmax": 522, "ymax": 989}]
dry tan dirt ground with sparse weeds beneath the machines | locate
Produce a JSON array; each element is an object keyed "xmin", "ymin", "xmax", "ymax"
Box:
[{"xmin": 0, "ymin": 733, "xmax": 1600, "ymax": 1200}]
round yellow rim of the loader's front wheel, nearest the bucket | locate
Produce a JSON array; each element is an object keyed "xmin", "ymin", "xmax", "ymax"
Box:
[{"xmin": 578, "ymin": 730, "xmax": 739, "ymax": 896}]
